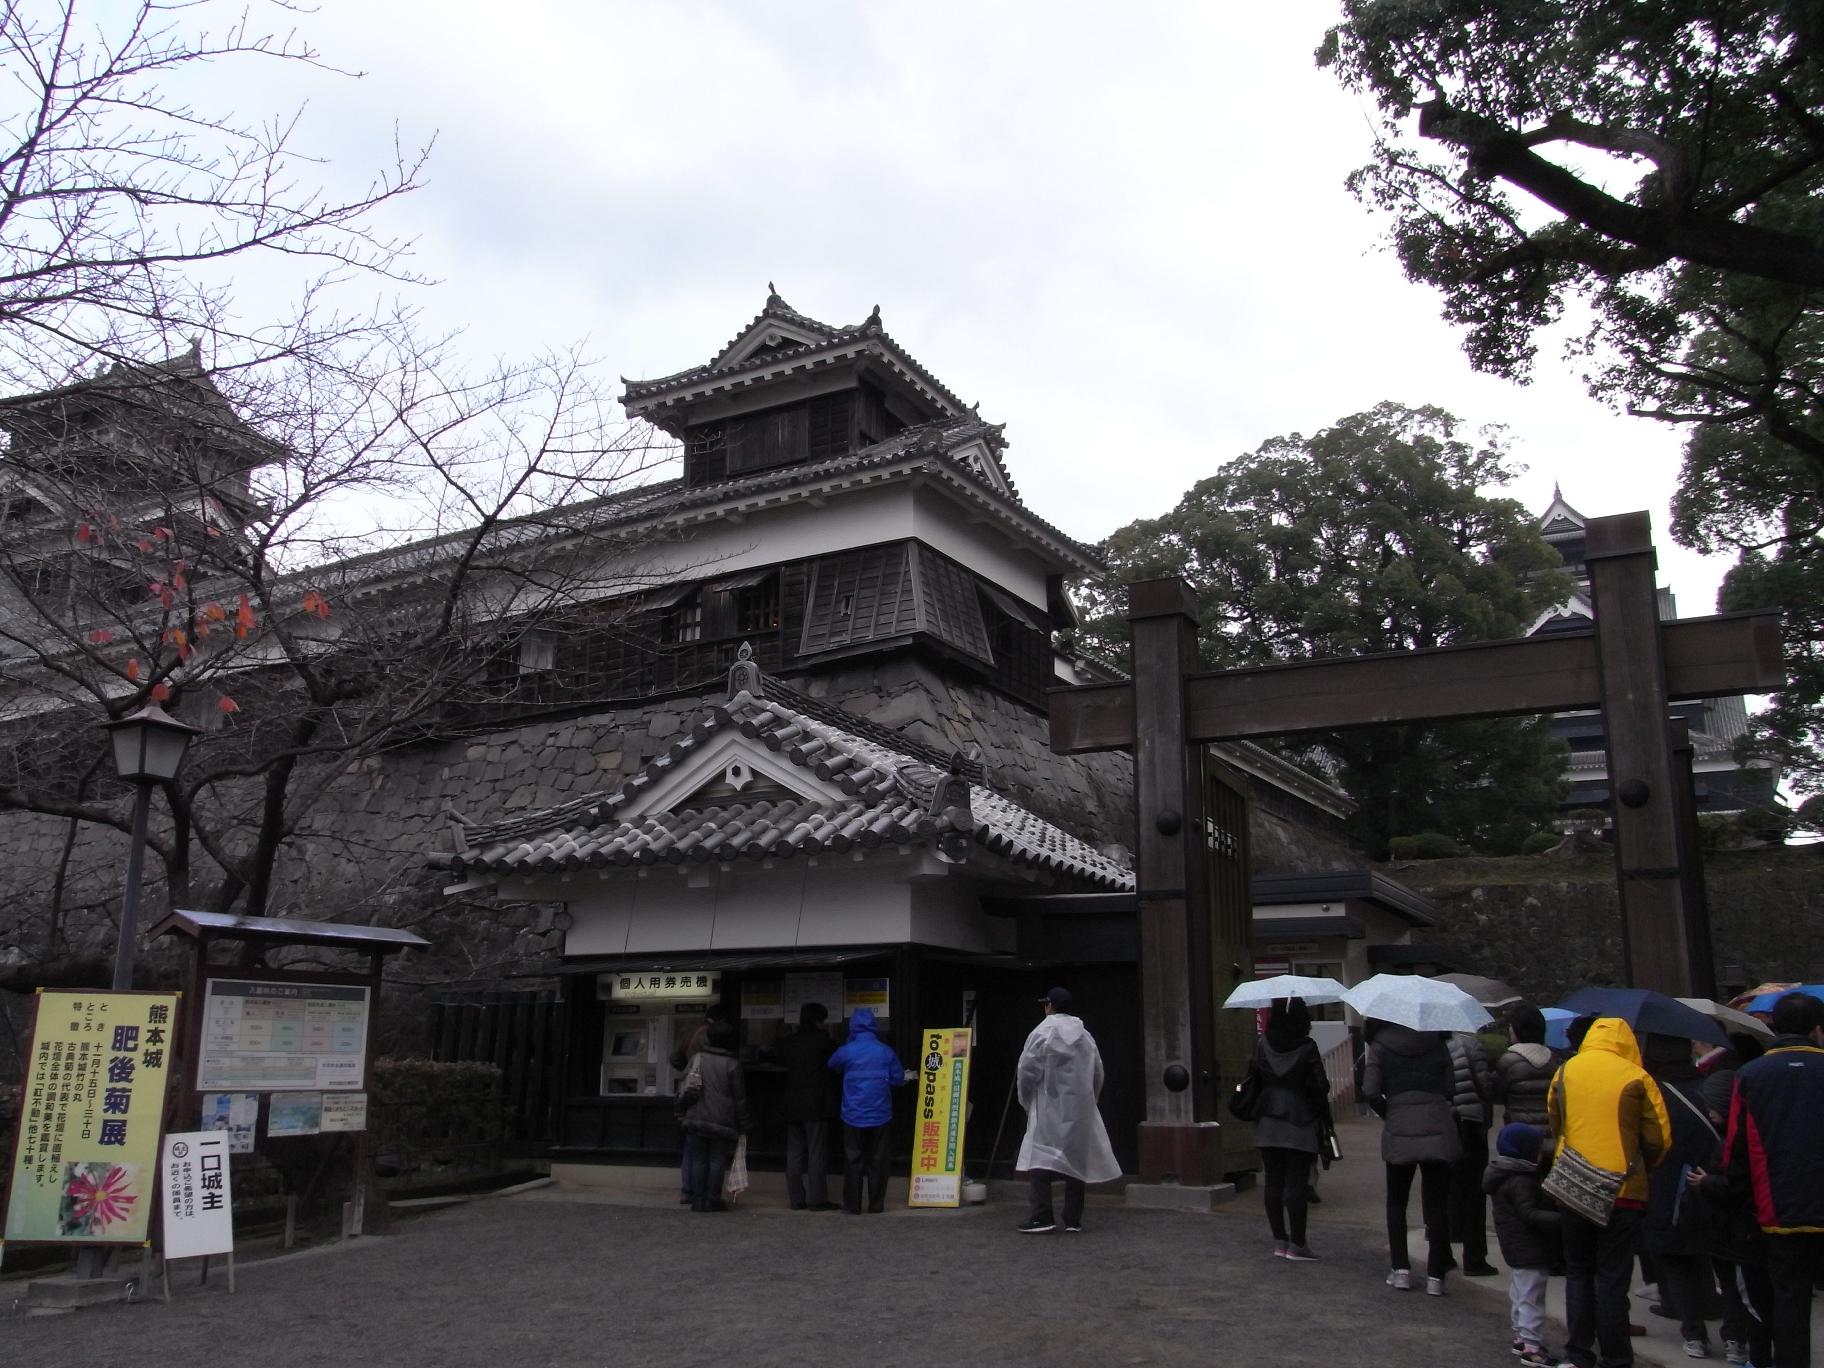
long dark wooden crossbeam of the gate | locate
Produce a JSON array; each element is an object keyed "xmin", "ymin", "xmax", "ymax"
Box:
[{"xmin": 1049, "ymin": 613, "xmax": 1786, "ymax": 755}]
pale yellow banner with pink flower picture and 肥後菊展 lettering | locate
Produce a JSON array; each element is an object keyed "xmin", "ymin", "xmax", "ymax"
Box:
[{"xmin": 5, "ymin": 990, "xmax": 179, "ymax": 1244}]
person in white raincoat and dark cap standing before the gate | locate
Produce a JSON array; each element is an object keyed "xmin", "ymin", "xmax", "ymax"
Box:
[{"xmin": 1014, "ymin": 989, "xmax": 1122, "ymax": 1235}]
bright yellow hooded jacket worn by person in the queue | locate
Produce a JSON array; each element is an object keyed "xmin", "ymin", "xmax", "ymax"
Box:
[{"xmin": 1547, "ymin": 1016, "xmax": 1673, "ymax": 1206}]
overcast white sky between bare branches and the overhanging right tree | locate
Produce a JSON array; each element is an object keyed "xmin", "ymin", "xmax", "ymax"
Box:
[{"xmin": 209, "ymin": 0, "xmax": 1727, "ymax": 615}]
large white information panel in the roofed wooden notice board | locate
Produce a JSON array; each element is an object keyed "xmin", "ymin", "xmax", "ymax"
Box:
[{"xmin": 197, "ymin": 978, "xmax": 368, "ymax": 1093}]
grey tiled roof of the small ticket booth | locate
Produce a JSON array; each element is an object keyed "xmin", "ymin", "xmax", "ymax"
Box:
[{"xmin": 434, "ymin": 689, "xmax": 1135, "ymax": 892}]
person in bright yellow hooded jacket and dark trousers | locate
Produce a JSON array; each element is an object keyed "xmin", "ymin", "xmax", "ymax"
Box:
[{"xmin": 1545, "ymin": 1016, "xmax": 1673, "ymax": 1368}]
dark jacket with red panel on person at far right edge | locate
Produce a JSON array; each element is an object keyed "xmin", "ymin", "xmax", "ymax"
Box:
[{"xmin": 1724, "ymin": 1036, "xmax": 1824, "ymax": 1235}]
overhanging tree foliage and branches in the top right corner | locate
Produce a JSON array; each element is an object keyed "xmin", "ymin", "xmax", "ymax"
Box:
[{"xmin": 1317, "ymin": 0, "xmax": 1824, "ymax": 790}]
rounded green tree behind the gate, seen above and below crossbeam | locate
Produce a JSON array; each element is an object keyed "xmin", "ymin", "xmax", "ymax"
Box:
[{"xmin": 1083, "ymin": 403, "xmax": 1572, "ymax": 857}]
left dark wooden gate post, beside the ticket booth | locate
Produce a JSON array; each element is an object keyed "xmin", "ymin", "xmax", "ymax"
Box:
[{"xmin": 1127, "ymin": 578, "xmax": 1222, "ymax": 1186}]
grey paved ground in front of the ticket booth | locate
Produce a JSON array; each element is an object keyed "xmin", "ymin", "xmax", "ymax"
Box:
[{"xmin": 0, "ymin": 1125, "xmax": 1802, "ymax": 1368}]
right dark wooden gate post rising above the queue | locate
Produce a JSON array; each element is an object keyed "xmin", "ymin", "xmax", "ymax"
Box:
[{"xmin": 1585, "ymin": 513, "xmax": 1698, "ymax": 998}]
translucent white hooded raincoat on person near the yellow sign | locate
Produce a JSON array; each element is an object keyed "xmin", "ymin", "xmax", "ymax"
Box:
[{"xmin": 1014, "ymin": 1012, "xmax": 1122, "ymax": 1182}]
